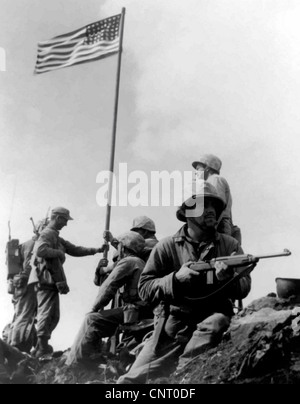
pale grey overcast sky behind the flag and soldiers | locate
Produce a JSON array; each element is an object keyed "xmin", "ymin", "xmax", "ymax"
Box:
[{"xmin": 0, "ymin": 0, "xmax": 300, "ymax": 349}]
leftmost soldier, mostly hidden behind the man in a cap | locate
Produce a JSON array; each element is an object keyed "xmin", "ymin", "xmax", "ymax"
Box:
[{"xmin": 9, "ymin": 219, "xmax": 48, "ymax": 353}]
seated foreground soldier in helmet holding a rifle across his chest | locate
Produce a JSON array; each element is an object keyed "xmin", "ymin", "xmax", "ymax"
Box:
[{"xmin": 118, "ymin": 179, "xmax": 255, "ymax": 384}]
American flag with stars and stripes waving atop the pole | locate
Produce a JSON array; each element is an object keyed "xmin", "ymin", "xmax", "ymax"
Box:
[{"xmin": 35, "ymin": 14, "xmax": 121, "ymax": 74}]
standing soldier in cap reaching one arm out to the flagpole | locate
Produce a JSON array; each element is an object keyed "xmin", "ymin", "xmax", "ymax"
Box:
[{"xmin": 29, "ymin": 207, "xmax": 105, "ymax": 357}]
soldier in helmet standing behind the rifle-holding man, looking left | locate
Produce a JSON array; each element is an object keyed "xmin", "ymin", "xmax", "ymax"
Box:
[{"xmin": 192, "ymin": 154, "xmax": 242, "ymax": 245}]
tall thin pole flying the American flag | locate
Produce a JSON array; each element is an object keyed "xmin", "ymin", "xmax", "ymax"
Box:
[{"xmin": 103, "ymin": 7, "xmax": 126, "ymax": 258}]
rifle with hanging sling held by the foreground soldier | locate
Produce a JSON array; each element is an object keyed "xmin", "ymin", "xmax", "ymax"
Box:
[{"xmin": 185, "ymin": 249, "xmax": 292, "ymax": 301}]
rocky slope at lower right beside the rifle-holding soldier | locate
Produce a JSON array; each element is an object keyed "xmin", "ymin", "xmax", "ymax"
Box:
[{"xmin": 169, "ymin": 296, "xmax": 300, "ymax": 384}]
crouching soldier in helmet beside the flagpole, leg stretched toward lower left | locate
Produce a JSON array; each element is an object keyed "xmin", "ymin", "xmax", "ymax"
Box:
[{"xmin": 67, "ymin": 231, "xmax": 147, "ymax": 365}]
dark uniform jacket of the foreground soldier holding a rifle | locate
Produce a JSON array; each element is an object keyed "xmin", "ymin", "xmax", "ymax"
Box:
[{"xmin": 139, "ymin": 225, "xmax": 251, "ymax": 317}]
